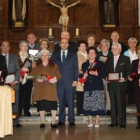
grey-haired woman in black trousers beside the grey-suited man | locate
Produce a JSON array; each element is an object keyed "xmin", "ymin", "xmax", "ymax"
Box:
[{"xmin": 19, "ymin": 40, "xmax": 32, "ymax": 116}]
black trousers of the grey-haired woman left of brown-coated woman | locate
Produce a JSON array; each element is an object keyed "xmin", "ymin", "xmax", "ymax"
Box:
[{"xmin": 19, "ymin": 80, "xmax": 33, "ymax": 113}]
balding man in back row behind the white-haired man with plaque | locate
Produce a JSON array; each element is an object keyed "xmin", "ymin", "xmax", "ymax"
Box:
[{"xmin": 109, "ymin": 31, "xmax": 128, "ymax": 54}]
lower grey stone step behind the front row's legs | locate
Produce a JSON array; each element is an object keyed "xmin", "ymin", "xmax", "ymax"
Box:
[{"xmin": 20, "ymin": 113, "xmax": 137, "ymax": 124}]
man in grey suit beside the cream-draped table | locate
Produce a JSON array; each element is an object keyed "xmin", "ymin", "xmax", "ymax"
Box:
[{"xmin": 1, "ymin": 41, "xmax": 22, "ymax": 128}]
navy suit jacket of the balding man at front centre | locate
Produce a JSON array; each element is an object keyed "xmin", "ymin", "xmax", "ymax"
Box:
[{"xmin": 52, "ymin": 51, "xmax": 78, "ymax": 89}]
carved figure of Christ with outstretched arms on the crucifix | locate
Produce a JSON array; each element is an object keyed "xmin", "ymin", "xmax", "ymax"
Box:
[{"xmin": 47, "ymin": 0, "xmax": 81, "ymax": 31}]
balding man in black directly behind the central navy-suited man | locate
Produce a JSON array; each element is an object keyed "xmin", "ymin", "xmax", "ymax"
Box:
[{"xmin": 54, "ymin": 31, "xmax": 78, "ymax": 53}]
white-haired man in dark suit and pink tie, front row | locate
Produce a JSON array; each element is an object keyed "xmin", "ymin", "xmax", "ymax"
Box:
[{"xmin": 107, "ymin": 43, "xmax": 131, "ymax": 129}]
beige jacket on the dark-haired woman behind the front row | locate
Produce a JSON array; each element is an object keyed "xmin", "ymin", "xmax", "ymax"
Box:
[{"xmin": 76, "ymin": 51, "xmax": 87, "ymax": 91}]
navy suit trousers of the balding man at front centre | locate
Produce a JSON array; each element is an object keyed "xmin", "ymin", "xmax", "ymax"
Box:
[{"xmin": 57, "ymin": 84, "xmax": 76, "ymax": 123}]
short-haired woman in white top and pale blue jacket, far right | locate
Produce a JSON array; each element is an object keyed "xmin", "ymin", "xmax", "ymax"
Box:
[{"xmin": 124, "ymin": 37, "xmax": 138, "ymax": 105}]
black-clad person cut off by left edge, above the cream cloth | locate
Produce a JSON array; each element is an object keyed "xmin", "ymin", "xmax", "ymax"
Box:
[{"xmin": 0, "ymin": 54, "xmax": 8, "ymax": 85}]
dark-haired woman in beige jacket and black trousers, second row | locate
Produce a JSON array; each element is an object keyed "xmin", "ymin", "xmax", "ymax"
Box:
[{"xmin": 76, "ymin": 40, "xmax": 87, "ymax": 115}]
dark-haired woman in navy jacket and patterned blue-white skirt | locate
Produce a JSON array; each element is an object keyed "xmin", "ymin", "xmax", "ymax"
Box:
[{"xmin": 80, "ymin": 47, "xmax": 106, "ymax": 128}]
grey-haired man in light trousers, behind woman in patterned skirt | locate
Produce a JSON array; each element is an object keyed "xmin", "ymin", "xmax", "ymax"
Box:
[{"xmin": 96, "ymin": 39, "xmax": 112, "ymax": 115}]
